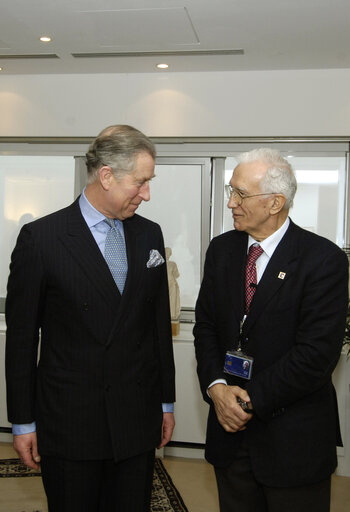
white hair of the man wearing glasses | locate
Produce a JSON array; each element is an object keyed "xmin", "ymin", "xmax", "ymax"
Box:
[{"xmin": 238, "ymin": 148, "xmax": 297, "ymax": 210}]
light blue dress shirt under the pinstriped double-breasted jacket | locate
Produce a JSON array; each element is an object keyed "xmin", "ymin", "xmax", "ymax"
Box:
[{"xmin": 12, "ymin": 189, "xmax": 174, "ymax": 436}]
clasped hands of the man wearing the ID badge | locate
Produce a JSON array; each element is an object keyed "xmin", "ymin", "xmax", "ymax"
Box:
[{"xmin": 208, "ymin": 383, "xmax": 252, "ymax": 432}]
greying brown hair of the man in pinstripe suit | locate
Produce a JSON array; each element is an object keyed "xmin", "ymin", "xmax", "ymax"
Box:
[{"xmin": 86, "ymin": 124, "xmax": 156, "ymax": 183}]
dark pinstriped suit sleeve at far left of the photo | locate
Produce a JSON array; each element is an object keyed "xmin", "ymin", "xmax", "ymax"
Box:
[{"xmin": 5, "ymin": 226, "xmax": 44, "ymax": 424}]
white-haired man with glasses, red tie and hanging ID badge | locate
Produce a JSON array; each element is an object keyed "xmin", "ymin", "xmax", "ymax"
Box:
[{"xmin": 194, "ymin": 149, "xmax": 348, "ymax": 512}]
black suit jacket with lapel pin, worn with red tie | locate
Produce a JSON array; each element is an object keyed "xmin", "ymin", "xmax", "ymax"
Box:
[{"xmin": 194, "ymin": 222, "xmax": 348, "ymax": 486}]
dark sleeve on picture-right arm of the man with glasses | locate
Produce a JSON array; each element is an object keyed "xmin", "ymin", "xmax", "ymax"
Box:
[{"xmin": 247, "ymin": 248, "xmax": 348, "ymax": 420}]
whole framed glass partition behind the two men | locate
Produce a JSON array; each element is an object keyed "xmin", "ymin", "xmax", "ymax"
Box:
[{"xmin": 0, "ymin": 141, "xmax": 349, "ymax": 320}]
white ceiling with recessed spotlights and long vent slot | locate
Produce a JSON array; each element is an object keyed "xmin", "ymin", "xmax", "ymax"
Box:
[{"xmin": 0, "ymin": 0, "xmax": 350, "ymax": 77}]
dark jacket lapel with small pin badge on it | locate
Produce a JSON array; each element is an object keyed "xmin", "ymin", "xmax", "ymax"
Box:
[{"xmin": 244, "ymin": 222, "xmax": 298, "ymax": 332}]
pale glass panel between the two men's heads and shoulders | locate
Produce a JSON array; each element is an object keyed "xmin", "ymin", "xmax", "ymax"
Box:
[{"xmin": 137, "ymin": 158, "xmax": 210, "ymax": 309}]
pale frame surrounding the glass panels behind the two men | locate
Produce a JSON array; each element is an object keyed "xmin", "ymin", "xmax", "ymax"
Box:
[{"xmin": 0, "ymin": 137, "xmax": 350, "ymax": 320}]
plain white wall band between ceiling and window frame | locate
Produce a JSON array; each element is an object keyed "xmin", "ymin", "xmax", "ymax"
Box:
[{"xmin": 0, "ymin": 69, "xmax": 350, "ymax": 136}]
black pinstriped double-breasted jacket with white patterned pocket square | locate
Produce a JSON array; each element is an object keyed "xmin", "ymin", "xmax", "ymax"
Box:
[{"xmin": 6, "ymin": 200, "xmax": 175, "ymax": 460}]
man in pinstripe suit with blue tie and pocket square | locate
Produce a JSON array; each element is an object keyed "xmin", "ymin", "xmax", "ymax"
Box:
[{"xmin": 6, "ymin": 125, "xmax": 175, "ymax": 512}]
